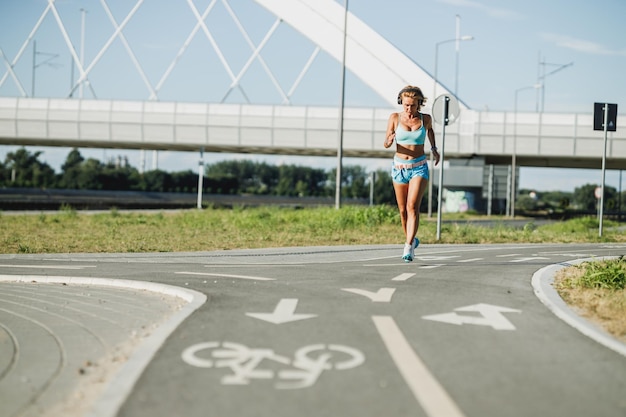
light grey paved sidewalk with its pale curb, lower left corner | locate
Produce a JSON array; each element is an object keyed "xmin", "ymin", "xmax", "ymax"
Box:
[{"xmin": 0, "ymin": 275, "xmax": 206, "ymax": 417}]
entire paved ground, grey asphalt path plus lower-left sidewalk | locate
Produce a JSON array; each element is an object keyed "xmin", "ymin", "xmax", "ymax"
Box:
[{"xmin": 0, "ymin": 245, "xmax": 626, "ymax": 417}]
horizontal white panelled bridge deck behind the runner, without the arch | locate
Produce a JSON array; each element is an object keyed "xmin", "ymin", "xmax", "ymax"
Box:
[{"xmin": 0, "ymin": 97, "xmax": 626, "ymax": 169}]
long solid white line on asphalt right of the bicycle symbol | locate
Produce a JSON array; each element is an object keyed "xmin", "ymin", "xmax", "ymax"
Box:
[{"xmin": 372, "ymin": 316, "xmax": 464, "ymax": 417}]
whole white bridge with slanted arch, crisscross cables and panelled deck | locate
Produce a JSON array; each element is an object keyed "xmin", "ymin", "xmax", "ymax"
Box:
[{"xmin": 0, "ymin": 0, "xmax": 626, "ymax": 169}]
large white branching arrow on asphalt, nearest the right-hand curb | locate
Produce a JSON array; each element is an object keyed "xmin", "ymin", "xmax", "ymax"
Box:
[{"xmin": 422, "ymin": 303, "xmax": 522, "ymax": 330}]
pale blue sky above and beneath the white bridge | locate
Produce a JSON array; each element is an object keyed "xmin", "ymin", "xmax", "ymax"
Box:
[{"xmin": 0, "ymin": 0, "xmax": 626, "ymax": 191}]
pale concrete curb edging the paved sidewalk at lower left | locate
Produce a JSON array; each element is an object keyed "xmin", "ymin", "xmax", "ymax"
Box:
[{"xmin": 0, "ymin": 275, "xmax": 207, "ymax": 417}]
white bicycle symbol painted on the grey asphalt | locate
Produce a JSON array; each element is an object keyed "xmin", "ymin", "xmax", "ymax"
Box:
[{"xmin": 181, "ymin": 342, "xmax": 365, "ymax": 389}]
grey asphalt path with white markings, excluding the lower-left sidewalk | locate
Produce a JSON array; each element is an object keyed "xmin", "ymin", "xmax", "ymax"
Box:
[{"xmin": 0, "ymin": 244, "xmax": 626, "ymax": 417}]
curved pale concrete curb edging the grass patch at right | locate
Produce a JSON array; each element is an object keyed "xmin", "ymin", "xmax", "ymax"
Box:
[{"xmin": 532, "ymin": 256, "xmax": 626, "ymax": 356}]
